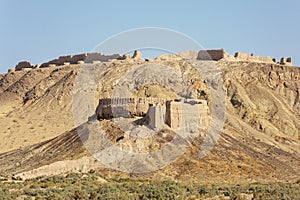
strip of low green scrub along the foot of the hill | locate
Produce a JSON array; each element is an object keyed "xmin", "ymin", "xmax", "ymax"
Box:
[{"xmin": 0, "ymin": 171, "xmax": 300, "ymax": 199}]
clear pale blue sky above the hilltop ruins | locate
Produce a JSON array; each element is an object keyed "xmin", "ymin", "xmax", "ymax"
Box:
[{"xmin": 0, "ymin": 0, "xmax": 300, "ymax": 73}]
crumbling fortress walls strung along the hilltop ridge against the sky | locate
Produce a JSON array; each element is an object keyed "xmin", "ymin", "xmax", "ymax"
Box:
[{"xmin": 9, "ymin": 49, "xmax": 292, "ymax": 72}]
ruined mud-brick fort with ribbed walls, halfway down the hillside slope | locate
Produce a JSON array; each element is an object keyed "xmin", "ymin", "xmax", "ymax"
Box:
[{"xmin": 96, "ymin": 97, "xmax": 209, "ymax": 129}]
